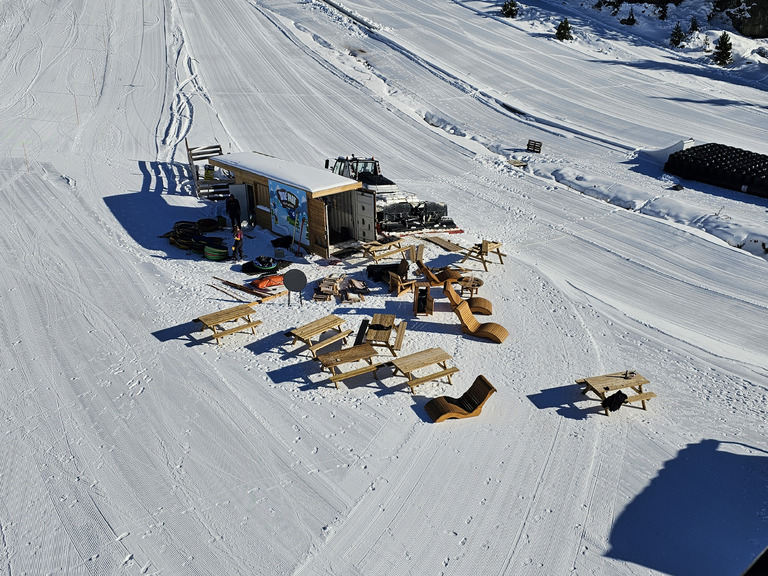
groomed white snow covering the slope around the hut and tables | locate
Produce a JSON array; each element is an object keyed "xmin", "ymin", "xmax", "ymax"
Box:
[{"xmin": 0, "ymin": 0, "xmax": 768, "ymax": 576}]
